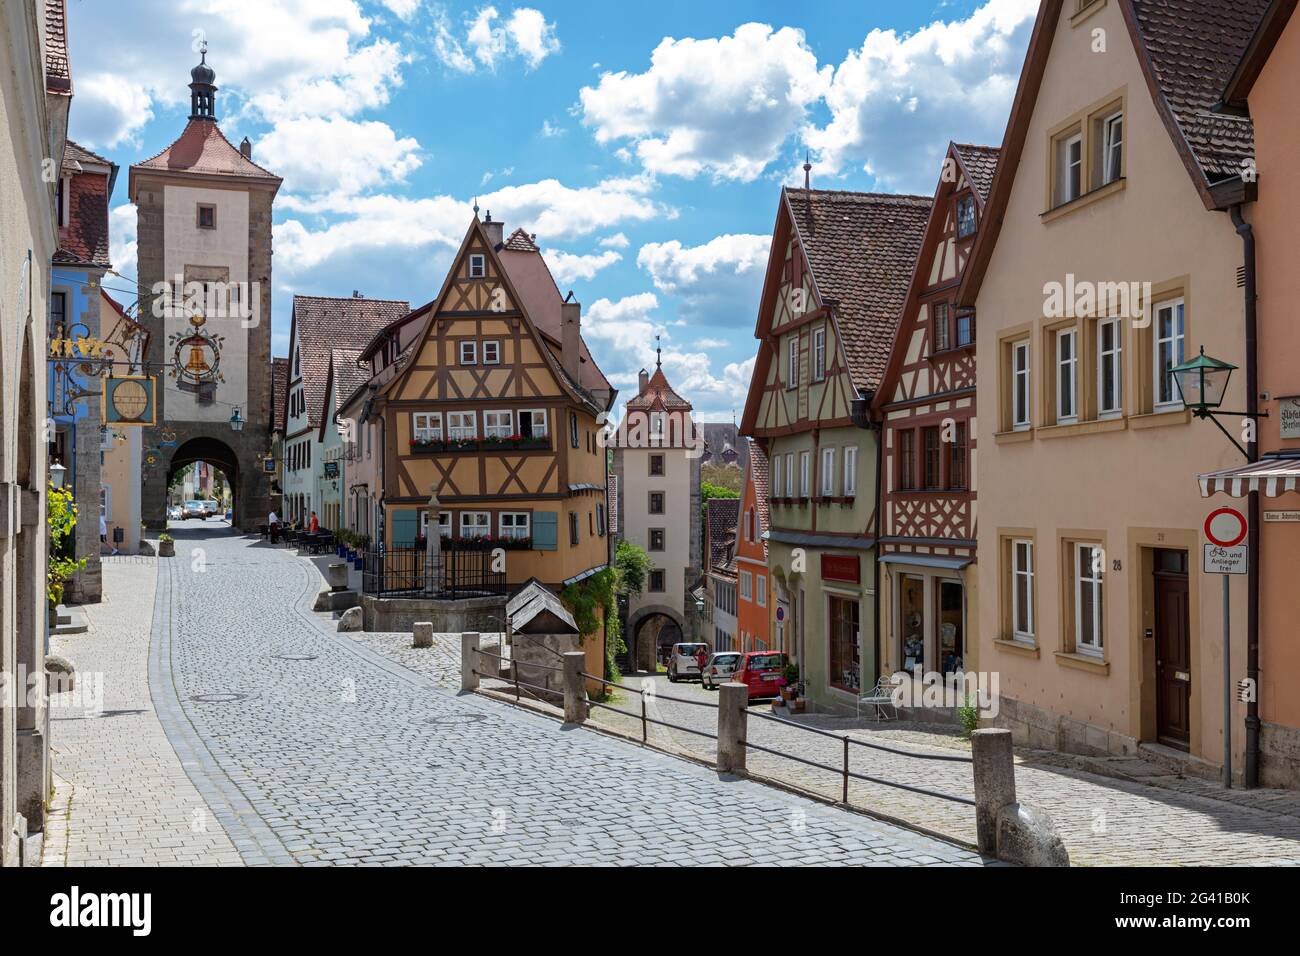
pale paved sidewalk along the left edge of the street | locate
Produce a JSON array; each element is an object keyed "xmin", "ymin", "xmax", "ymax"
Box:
[{"xmin": 44, "ymin": 557, "xmax": 241, "ymax": 866}]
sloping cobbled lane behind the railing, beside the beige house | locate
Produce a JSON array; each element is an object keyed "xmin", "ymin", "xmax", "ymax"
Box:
[{"xmin": 592, "ymin": 675, "xmax": 1300, "ymax": 866}]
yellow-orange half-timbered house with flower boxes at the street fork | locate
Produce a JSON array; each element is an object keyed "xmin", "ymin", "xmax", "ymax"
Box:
[{"xmin": 367, "ymin": 213, "xmax": 615, "ymax": 589}]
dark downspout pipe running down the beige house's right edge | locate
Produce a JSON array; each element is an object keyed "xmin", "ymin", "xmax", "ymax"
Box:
[{"xmin": 1229, "ymin": 203, "xmax": 1261, "ymax": 790}]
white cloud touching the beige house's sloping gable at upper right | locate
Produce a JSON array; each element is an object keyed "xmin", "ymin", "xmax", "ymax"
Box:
[{"xmin": 803, "ymin": 0, "xmax": 1039, "ymax": 191}]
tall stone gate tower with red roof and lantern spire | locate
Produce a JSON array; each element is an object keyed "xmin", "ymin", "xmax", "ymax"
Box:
[{"xmin": 130, "ymin": 49, "xmax": 281, "ymax": 529}]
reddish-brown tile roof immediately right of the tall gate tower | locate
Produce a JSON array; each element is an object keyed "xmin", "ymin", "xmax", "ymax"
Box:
[{"xmin": 286, "ymin": 295, "xmax": 411, "ymax": 428}]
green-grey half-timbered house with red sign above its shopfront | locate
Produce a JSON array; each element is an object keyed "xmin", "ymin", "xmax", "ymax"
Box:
[{"xmin": 741, "ymin": 189, "xmax": 931, "ymax": 710}]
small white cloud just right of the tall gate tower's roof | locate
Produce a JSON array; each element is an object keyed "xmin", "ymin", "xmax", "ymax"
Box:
[{"xmin": 257, "ymin": 117, "xmax": 420, "ymax": 193}]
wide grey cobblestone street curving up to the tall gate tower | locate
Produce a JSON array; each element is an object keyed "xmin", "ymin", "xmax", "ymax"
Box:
[{"xmin": 108, "ymin": 527, "xmax": 984, "ymax": 865}]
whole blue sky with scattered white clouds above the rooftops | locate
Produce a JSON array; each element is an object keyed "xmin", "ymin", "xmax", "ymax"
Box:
[{"xmin": 68, "ymin": 0, "xmax": 1037, "ymax": 420}]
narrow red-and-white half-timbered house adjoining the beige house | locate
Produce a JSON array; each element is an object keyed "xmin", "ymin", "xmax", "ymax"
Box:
[{"xmin": 874, "ymin": 143, "xmax": 998, "ymax": 675}]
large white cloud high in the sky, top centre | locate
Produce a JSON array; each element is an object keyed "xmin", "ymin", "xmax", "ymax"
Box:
[{"xmin": 579, "ymin": 23, "xmax": 831, "ymax": 181}]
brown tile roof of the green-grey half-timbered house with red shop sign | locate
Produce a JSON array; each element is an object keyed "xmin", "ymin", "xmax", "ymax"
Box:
[{"xmin": 784, "ymin": 189, "xmax": 931, "ymax": 392}]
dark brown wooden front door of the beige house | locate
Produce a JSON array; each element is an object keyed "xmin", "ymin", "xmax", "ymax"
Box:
[{"xmin": 1156, "ymin": 551, "xmax": 1192, "ymax": 750}]
